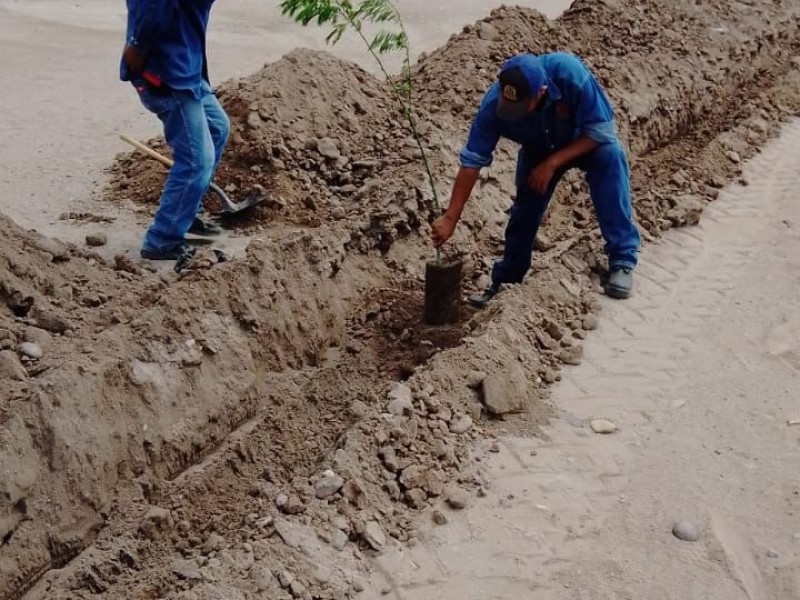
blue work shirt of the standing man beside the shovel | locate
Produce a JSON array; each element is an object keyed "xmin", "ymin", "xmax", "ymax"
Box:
[{"xmin": 120, "ymin": 0, "xmax": 214, "ymax": 98}]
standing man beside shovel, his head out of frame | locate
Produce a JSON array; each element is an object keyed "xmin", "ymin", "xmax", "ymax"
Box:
[{"xmin": 120, "ymin": 0, "xmax": 230, "ymax": 260}]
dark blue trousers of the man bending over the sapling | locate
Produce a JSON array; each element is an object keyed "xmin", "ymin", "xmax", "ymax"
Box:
[{"xmin": 492, "ymin": 143, "xmax": 640, "ymax": 284}]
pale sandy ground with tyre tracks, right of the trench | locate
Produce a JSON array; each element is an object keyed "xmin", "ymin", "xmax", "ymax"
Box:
[{"xmin": 367, "ymin": 122, "xmax": 800, "ymax": 600}]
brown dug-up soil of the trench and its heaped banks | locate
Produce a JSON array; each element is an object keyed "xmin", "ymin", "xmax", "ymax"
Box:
[{"xmin": 0, "ymin": 0, "xmax": 800, "ymax": 599}]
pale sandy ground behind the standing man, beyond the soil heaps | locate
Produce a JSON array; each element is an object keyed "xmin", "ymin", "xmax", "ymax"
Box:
[{"xmin": 0, "ymin": 0, "xmax": 569, "ymax": 256}]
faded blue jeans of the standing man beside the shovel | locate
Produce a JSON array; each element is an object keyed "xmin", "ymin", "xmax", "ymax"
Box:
[{"xmin": 134, "ymin": 81, "xmax": 230, "ymax": 252}]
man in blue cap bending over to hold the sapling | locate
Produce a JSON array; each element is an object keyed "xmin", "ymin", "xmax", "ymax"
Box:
[{"xmin": 431, "ymin": 52, "xmax": 639, "ymax": 308}]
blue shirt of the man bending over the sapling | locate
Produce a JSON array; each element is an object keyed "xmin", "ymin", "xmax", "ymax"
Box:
[{"xmin": 459, "ymin": 52, "xmax": 617, "ymax": 169}]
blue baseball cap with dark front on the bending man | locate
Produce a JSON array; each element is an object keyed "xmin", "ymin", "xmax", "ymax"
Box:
[{"xmin": 496, "ymin": 54, "xmax": 547, "ymax": 121}]
